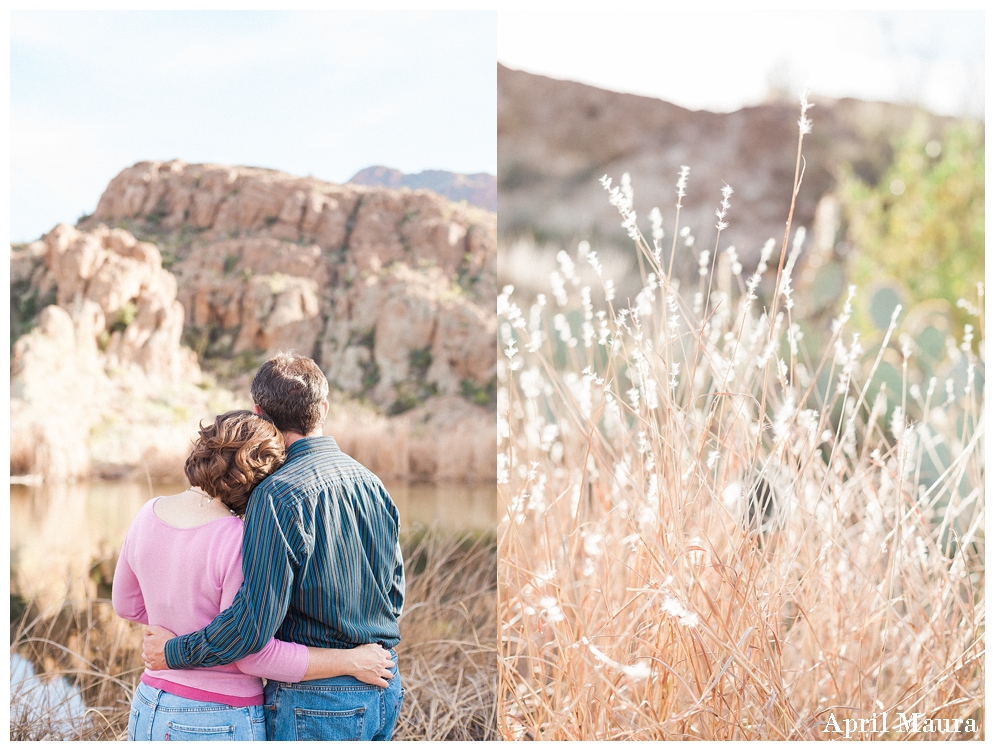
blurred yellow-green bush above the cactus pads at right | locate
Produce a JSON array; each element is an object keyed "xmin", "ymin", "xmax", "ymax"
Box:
[{"xmin": 840, "ymin": 122, "xmax": 985, "ymax": 329}]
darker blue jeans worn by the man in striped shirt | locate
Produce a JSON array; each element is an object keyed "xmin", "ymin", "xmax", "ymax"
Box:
[{"xmin": 263, "ymin": 650, "xmax": 404, "ymax": 741}]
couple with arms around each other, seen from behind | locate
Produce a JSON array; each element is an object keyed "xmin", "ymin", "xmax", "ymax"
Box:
[{"xmin": 113, "ymin": 354, "xmax": 404, "ymax": 740}]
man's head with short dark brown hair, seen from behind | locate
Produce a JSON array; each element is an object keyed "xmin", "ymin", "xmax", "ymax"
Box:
[{"xmin": 251, "ymin": 352, "xmax": 328, "ymax": 435}]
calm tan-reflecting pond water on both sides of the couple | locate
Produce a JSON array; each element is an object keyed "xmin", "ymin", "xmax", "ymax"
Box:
[{"xmin": 10, "ymin": 482, "xmax": 497, "ymax": 602}]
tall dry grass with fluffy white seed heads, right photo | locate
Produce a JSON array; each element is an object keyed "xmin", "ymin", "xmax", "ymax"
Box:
[{"xmin": 498, "ymin": 98, "xmax": 985, "ymax": 740}]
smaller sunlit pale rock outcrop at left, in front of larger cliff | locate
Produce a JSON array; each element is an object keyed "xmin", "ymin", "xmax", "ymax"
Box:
[{"xmin": 11, "ymin": 224, "xmax": 212, "ymax": 480}]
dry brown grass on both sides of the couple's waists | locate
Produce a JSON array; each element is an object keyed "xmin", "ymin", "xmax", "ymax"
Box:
[{"xmin": 10, "ymin": 531, "xmax": 497, "ymax": 740}]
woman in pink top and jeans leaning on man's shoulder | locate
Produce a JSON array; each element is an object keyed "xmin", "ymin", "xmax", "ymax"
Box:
[{"xmin": 112, "ymin": 410, "xmax": 394, "ymax": 741}]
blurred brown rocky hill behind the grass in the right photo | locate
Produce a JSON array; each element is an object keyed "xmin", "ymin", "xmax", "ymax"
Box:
[{"xmin": 497, "ymin": 65, "xmax": 945, "ymax": 273}]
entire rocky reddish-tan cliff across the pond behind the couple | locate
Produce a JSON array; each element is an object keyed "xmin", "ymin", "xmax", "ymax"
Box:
[{"xmin": 11, "ymin": 161, "xmax": 496, "ymax": 479}]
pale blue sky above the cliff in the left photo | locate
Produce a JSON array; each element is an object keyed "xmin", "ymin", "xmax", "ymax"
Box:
[{"xmin": 10, "ymin": 11, "xmax": 497, "ymax": 241}]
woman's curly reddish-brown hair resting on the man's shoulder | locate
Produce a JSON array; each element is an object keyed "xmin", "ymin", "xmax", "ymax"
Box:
[{"xmin": 183, "ymin": 409, "xmax": 286, "ymax": 516}]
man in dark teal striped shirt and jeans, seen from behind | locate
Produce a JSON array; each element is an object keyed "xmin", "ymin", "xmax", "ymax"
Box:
[{"xmin": 143, "ymin": 353, "xmax": 404, "ymax": 740}]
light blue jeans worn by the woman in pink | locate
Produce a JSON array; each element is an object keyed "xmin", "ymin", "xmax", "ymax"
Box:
[{"xmin": 128, "ymin": 683, "xmax": 266, "ymax": 741}]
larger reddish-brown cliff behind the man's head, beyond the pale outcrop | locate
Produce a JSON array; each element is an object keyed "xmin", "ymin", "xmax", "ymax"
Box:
[{"xmin": 86, "ymin": 161, "xmax": 496, "ymax": 412}]
